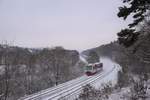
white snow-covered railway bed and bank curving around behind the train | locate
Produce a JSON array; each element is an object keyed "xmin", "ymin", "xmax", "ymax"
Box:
[{"xmin": 19, "ymin": 58, "xmax": 120, "ymax": 100}]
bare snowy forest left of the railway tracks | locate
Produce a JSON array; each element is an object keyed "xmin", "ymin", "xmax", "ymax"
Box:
[{"xmin": 0, "ymin": 45, "xmax": 84, "ymax": 100}]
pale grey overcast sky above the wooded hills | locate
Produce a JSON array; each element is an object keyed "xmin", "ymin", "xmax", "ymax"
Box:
[{"xmin": 0, "ymin": 0, "xmax": 129, "ymax": 50}]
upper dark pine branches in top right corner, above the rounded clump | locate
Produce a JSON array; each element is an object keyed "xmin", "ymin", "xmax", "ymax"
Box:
[{"xmin": 118, "ymin": 0, "xmax": 150, "ymax": 28}]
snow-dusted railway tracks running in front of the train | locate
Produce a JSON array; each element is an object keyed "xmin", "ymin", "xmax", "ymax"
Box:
[{"xmin": 19, "ymin": 67, "xmax": 115, "ymax": 100}]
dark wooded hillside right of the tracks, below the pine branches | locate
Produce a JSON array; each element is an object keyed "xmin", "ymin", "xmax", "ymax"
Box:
[{"xmin": 82, "ymin": 34, "xmax": 150, "ymax": 74}]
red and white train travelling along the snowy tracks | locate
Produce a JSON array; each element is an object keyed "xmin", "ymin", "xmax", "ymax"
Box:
[{"xmin": 84, "ymin": 63, "xmax": 103, "ymax": 76}]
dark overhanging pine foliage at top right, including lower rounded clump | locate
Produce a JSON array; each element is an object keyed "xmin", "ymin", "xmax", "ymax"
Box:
[{"xmin": 117, "ymin": 0, "xmax": 150, "ymax": 47}]
